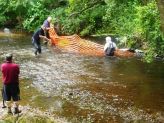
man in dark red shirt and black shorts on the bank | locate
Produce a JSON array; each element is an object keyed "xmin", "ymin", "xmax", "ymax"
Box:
[{"xmin": 1, "ymin": 54, "xmax": 21, "ymax": 114}]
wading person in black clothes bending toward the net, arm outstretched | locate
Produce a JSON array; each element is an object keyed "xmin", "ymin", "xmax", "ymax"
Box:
[{"xmin": 32, "ymin": 25, "xmax": 50, "ymax": 55}]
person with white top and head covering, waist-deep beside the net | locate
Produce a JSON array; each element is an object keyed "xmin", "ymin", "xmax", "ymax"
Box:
[{"xmin": 104, "ymin": 37, "xmax": 117, "ymax": 56}]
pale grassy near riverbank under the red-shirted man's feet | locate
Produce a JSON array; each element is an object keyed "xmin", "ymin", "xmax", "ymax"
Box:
[{"xmin": 0, "ymin": 103, "xmax": 68, "ymax": 123}]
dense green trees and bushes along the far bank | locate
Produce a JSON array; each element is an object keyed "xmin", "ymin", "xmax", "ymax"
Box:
[{"xmin": 0, "ymin": 0, "xmax": 164, "ymax": 62}]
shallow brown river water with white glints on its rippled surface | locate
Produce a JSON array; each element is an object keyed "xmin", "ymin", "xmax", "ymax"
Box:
[{"xmin": 0, "ymin": 31, "xmax": 164, "ymax": 123}]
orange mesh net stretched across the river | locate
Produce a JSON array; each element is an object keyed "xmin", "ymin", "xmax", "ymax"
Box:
[{"xmin": 49, "ymin": 28, "xmax": 134, "ymax": 57}]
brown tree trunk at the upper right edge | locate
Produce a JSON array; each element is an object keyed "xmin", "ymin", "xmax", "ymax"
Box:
[{"xmin": 156, "ymin": 0, "xmax": 164, "ymax": 34}]
